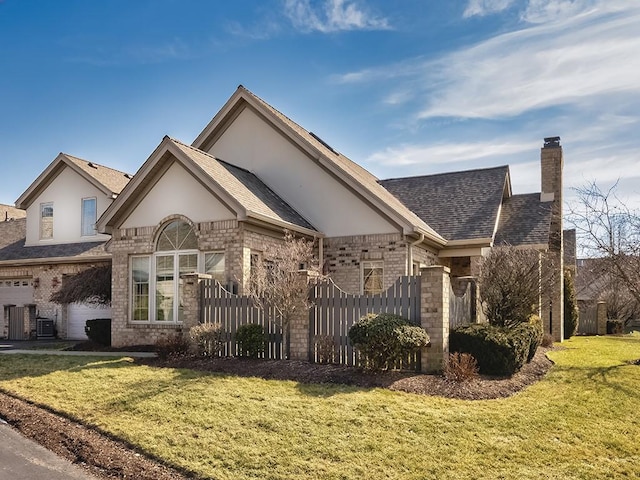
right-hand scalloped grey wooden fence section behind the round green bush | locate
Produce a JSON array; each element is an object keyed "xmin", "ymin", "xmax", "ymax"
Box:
[{"xmin": 309, "ymin": 276, "xmax": 420, "ymax": 369}]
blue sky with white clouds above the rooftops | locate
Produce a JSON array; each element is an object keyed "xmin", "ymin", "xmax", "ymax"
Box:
[{"xmin": 0, "ymin": 0, "xmax": 640, "ymax": 208}]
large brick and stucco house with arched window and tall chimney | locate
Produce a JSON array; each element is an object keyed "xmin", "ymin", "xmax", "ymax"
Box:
[{"xmin": 95, "ymin": 86, "xmax": 563, "ymax": 345}]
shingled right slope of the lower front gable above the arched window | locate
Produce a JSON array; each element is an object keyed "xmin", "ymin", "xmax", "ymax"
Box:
[{"xmin": 170, "ymin": 139, "xmax": 316, "ymax": 230}]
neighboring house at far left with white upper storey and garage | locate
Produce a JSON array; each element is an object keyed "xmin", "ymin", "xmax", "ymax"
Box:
[{"xmin": 0, "ymin": 153, "xmax": 130, "ymax": 339}]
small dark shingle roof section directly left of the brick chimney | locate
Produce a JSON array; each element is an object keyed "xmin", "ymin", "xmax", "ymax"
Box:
[{"xmin": 495, "ymin": 193, "xmax": 553, "ymax": 246}]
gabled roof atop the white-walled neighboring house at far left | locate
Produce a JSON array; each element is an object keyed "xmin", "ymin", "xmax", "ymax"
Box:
[{"xmin": 16, "ymin": 153, "xmax": 131, "ymax": 209}]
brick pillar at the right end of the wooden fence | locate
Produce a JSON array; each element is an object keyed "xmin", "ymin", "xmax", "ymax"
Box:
[{"xmin": 420, "ymin": 265, "xmax": 451, "ymax": 372}]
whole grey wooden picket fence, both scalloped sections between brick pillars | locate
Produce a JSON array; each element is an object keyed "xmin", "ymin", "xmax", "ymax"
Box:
[{"xmin": 200, "ymin": 276, "xmax": 420, "ymax": 369}]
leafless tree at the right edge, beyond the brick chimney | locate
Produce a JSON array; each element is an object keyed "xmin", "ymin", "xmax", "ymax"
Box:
[{"xmin": 567, "ymin": 182, "xmax": 640, "ymax": 319}]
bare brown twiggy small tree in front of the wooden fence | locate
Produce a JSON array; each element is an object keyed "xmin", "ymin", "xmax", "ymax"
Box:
[{"xmin": 249, "ymin": 232, "xmax": 320, "ymax": 357}]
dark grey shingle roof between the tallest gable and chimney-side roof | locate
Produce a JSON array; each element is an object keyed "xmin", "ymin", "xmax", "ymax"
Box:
[{"xmin": 379, "ymin": 166, "xmax": 511, "ymax": 242}]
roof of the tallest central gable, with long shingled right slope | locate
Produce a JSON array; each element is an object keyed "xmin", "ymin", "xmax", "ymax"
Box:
[{"xmin": 192, "ymin": 85, "xmax": 446, "ymax": 246}]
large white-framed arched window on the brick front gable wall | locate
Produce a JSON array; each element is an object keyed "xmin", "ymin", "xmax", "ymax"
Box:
[{"xmin": 130, "ymin": 221, "xmax": 225, "ymax": 323}]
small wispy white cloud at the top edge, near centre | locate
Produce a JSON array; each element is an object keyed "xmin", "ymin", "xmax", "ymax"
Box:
[{"xmin": 284, "ymin": 0, "xmax": 391, "ymax": 33}]
